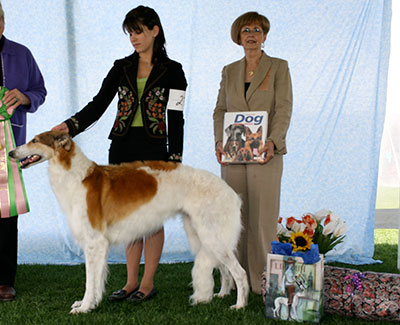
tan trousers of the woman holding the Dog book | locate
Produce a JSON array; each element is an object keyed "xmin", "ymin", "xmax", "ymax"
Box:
[{"xmin": 221, "ymin": 154, "xmax": 283, "ymax": 294}]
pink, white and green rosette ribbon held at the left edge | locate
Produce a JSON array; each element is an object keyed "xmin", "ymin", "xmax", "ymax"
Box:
[{"xmin": 0, "ymin": 87, "xmax": 29, "ymax": 218}]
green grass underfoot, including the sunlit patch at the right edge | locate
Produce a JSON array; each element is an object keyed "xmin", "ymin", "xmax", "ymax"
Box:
[{"xmin": 0, "ymin": 229, "xmax": 399, "ymax": 325}]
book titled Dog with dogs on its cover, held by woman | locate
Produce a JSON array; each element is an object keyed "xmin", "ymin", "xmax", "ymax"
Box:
[{"xmin": 222, "ymin": 111, "xmax": 268, "ymax": 164}]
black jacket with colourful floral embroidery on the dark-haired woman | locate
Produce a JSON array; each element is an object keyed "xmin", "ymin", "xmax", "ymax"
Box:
[{"xmin": 65, "ymin": 52, "xmax": 187, "ymax": 161}]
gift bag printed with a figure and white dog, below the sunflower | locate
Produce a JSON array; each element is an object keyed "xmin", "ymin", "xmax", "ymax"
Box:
[{"xmin": 263, "ymin": 254, "xmax": 324, "ymax": 323}]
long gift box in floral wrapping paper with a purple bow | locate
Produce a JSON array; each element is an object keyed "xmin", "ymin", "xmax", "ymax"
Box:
[{"xmin": 324, "ymin": 266, "xmax": 400, "ymax": 321}]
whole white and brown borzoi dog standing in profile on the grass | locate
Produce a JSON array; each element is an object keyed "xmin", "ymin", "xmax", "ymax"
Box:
[{"xmin": 10, "ymin": 131, "xmax": 249, "ymax": 313}]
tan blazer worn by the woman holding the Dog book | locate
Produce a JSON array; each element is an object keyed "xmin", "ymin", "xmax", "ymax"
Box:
[{"xmin": 213, "ymin": 52, "xmax": 292, "ymax": 154}]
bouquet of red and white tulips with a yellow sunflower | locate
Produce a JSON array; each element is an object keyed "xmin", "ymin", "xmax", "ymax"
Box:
[{"xmin": 277, "ymin": 210, "xmax": 347, "ymax": 255}]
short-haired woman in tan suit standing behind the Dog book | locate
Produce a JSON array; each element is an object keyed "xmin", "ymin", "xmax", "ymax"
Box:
[{"xmin": 213, "ymin": 12, "xmax": 292, "ymax": 294}]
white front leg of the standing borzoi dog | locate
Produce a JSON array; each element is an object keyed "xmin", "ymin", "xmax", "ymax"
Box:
[{"xmin": 71, "ymin": 238, "xmax": 108, "ymax": 314}]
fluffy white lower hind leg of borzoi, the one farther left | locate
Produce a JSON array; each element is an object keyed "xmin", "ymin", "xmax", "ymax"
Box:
[{"xmin": 190, "ymin": 247, "xmax": 218, "ymax": 305}]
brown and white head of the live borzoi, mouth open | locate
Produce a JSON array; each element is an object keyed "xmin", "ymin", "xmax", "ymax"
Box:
[{"xmin": 9, "ymin": 131, "xmax": 73, "ymax": 168}]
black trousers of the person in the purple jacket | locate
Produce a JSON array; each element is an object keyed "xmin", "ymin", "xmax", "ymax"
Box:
[{"xmin": 0, "ymin": 216, "xmax": 18, "ymax": 287}]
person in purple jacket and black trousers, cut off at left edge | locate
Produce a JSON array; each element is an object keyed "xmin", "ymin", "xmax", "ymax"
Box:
[{"xmin": 0, "ymin": 3, "xmax": 47, "ymax": 301}]
